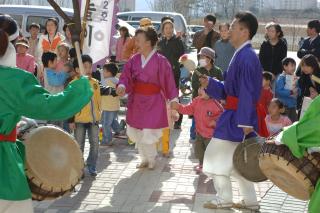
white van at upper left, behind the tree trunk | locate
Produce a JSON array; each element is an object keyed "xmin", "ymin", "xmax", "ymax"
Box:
[{"xmin": 0, "ymin": 5, "xmax": 73, "ymax": 36}]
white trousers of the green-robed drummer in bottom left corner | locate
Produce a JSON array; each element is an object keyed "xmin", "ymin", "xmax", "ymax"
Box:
[{"xmin": 0, "ymin": 199, "xmax": 33, "ymax": 213}]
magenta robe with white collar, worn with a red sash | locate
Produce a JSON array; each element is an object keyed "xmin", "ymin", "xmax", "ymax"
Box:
[{"xmin": 119, "ymin": 50, "xmax": 178, "ymax": 129}]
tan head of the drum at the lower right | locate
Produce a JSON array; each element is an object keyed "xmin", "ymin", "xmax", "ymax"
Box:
[{"xmin": 259, "ymin": 154, "xmax": 314, "ymax": 200}]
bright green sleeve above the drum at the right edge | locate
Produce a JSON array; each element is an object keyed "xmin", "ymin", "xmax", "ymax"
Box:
[{"xmin": 281, "ymin": 96, "xmax": 320, "ymax": 158}]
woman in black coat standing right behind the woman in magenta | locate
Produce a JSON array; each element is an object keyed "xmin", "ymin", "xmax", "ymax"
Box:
[{"xmin": 158, "ymin": 19, "xmax": 185, "ymax": 129}]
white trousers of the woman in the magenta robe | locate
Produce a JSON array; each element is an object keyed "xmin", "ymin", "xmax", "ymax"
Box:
[{"xmin": 127, "ymin": 125, "xmax": 162, "ymax": 163}]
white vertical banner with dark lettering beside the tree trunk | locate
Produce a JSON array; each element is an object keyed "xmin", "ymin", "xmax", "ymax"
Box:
[{"xmin": 81, "ymin": 0, "xmax": 116, "ymax": 63}]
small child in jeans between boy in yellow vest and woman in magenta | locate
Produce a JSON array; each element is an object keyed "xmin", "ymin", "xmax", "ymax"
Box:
[{"xmin": 101, "ymin": 63, "xmax": 120, "ymax": 146}]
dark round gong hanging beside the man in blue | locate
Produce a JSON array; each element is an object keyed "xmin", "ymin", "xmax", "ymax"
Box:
[{"xmin": 233, "ymin": 138, "xmax": 268, "ymax": 182}]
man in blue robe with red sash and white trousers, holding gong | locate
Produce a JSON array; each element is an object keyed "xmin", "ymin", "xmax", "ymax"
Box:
[{"xmin": 200, "ymin": 12, "xmax": 268, "ymax": 210}]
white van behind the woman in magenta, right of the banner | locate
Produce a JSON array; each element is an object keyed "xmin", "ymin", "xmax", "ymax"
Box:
[{"xmin": 117, "ymin": 11, "xmax": 190, "ymax": 47}]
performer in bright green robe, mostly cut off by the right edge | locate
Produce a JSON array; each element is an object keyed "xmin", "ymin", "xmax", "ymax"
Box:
[{"xmin": 277, "ymin": 96, "xmax": 320, "ymax": 213}]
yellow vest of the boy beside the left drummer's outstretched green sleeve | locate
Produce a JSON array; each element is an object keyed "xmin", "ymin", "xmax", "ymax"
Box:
[{"xmin": 75, "ymin": 78, "xmax": 101, "ymax": 123}]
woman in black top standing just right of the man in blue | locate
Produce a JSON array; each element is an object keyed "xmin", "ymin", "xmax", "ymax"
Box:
[{"xmin": 259, "ymin": 22, "xmax": 288, "ymax": 76}]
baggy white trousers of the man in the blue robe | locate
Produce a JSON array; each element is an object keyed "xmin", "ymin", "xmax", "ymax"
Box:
[{"xmin": 203, "ymin": 138, "xmax": 258, "ymax": 205}]
